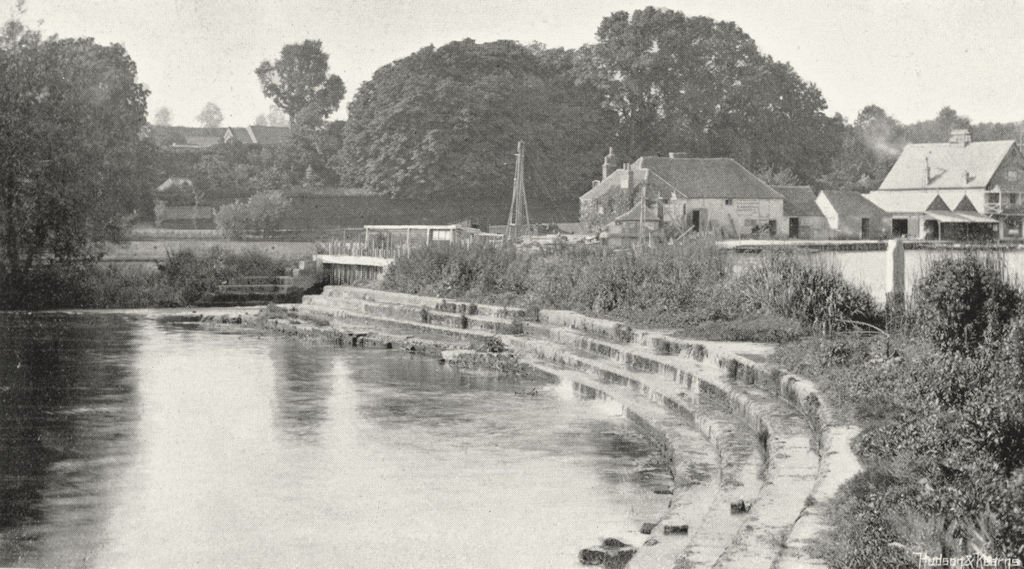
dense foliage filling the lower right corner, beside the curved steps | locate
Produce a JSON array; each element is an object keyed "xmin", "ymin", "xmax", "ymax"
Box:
[{"xmin": 775, "ymin": 254, "xmax": 1024, "ymax": 568}]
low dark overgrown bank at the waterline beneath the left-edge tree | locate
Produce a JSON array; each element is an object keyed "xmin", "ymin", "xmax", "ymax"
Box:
[{"xmin": 0, "ymin": 248, "xmax": 288, "ymax": 310}]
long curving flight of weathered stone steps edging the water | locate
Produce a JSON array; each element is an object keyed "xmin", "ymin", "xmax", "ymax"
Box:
[{"xmin": 294, "ymin": 287, "xmax": 857, "ymax": 568}]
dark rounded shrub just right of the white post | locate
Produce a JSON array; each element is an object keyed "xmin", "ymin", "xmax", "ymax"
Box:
[{"xmin": 913, "ymin": 254, "xmax": 1021, "ymax": 353}]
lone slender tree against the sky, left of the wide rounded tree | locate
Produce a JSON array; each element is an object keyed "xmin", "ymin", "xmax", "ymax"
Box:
[{"xmin": 256, "ymin": 40, "xmax": 345, "ymax": 123}]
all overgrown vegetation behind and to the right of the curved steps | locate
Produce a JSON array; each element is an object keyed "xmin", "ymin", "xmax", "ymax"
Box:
[{"xmin": 383, "ymin": 240, "xmax": 1024, "ymax": 568}]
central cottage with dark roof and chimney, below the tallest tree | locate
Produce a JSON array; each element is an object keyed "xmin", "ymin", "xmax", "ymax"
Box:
[{"xmin": 580, "ymin": 148, "xmax": 783, "ymax": 240}]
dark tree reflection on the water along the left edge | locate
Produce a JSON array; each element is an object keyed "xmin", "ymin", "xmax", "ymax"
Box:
[{"xmin": 0, "ymin": 315, "xmax": 139, "ymax": 566}]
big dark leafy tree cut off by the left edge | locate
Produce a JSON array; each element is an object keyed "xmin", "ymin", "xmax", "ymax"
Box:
[{"xmin": 0, "ymin": 21, "xmax": 147, "ymax": 286}]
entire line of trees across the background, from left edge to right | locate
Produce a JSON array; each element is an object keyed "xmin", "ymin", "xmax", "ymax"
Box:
[{"xmin": 6, "ymin": 4, "xmax": 1022, "ymax": 288}]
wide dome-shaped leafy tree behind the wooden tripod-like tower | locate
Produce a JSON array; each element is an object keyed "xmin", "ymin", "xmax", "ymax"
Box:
[{"xmin": 335, "ymin": 40, "xmax": 612, "ymax": 206}]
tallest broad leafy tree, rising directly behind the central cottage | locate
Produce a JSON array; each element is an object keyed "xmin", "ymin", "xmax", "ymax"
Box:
[{"xmin": 578, "ymin": 7, "xmax": 842, "ymax": 180}]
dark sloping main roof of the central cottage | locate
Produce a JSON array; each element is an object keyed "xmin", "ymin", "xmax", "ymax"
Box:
[{"xmin": 633, "ymin": 157, "xmax": 782, "ymax": 200}]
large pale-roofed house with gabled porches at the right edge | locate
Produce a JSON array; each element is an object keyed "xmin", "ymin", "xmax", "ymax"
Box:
[{"xmin": 865, "ymin": 130, "xmax": 1024, "ymax": 240}]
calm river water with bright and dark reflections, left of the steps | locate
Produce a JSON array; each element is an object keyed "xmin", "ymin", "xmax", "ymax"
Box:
[{"xmin": 0, "ymin": 314, "xmax": 668, "ymax": 568}]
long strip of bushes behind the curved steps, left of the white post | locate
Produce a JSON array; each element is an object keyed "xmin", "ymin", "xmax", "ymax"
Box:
[{"xmin": 383, "ymin": 239, "xmax": 884, "ymax": 341}]
